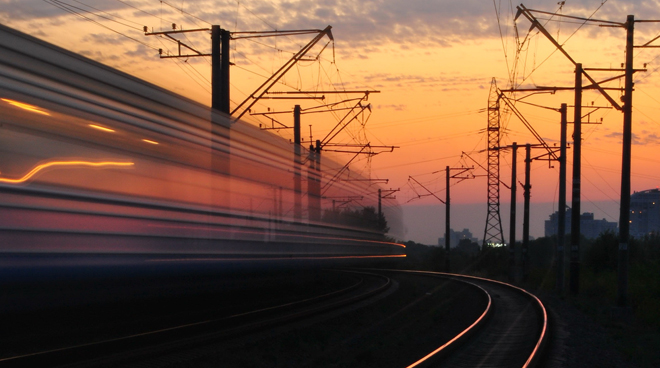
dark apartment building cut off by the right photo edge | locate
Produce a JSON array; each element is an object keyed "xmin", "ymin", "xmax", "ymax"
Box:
[{"xmin": 630, "ymin": 189, "xmax": 660, "ymax": 237}]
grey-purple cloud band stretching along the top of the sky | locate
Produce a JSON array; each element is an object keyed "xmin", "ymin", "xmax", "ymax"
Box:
[{"xmin": 5, "ymin": 0, "xmax": 660, "ymax": 57}]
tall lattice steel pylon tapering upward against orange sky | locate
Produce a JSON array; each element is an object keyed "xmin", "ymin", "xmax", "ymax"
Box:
[{"xmin": 483, "ymin": 78, "xmax": 506, "ymax": 247}]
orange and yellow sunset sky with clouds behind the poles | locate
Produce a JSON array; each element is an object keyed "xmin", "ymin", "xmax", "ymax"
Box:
[{"xmin": 0, "ymin": 0, "xmax": 660, "ymax": 243}]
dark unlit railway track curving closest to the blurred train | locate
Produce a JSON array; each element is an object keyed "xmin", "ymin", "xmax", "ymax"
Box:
[{"xmin": 0, "ymin": 271, "xmax": 392, "ymax": 367}]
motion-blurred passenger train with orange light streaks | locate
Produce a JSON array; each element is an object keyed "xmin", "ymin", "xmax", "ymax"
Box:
[{"xmin": 0, "ymin": 26, "xmax": 405, "ymax": 267}]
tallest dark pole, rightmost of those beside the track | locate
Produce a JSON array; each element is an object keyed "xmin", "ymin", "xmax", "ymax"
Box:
[{"xmin": 617, "ymin": 15, "xmax": 635, "ymax": 307}]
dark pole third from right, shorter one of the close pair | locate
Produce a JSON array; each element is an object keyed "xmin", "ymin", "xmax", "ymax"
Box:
[{"xmin": 555, "ymin": 103, "xmax": 568, "ymax": 295}]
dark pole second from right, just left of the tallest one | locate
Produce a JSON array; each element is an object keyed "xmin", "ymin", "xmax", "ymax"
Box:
[{"xmin": 570, "ymin": 63, "xmax": 583, "ymax": 295}]
